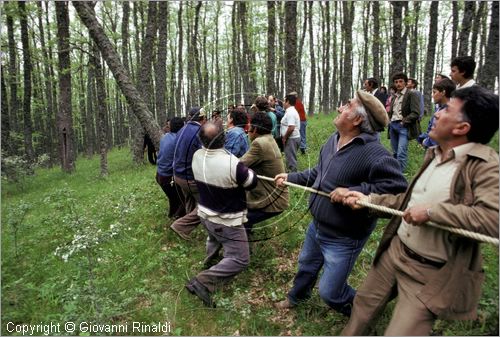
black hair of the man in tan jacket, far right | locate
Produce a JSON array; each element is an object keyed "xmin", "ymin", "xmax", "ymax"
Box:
[{"xmin": 451, "ymin": 85, "xmax": 499, "ymax": 144}]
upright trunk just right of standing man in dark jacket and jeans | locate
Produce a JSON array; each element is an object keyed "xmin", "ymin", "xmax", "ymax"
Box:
[{"xmin": 424, "ymin": 1, "xmax": 439, "ymax": 113}]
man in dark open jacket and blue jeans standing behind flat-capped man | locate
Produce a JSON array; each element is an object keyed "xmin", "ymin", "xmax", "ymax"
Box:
[{"xmin": 389, "ymin": 73, "xmax": 421, "ymax": 172}]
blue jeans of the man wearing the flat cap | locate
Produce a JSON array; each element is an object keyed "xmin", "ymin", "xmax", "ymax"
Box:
[{"xmin": 288, "ymin": 220, "xmax": 368, "ymax": 310}]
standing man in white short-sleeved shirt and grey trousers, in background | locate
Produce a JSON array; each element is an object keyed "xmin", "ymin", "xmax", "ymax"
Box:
[{"xmin": 280, "ymin": 94, "xmax": 300, "ymax": 172}]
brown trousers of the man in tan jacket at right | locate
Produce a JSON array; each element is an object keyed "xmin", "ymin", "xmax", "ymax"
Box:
[{"xmin": 342, "ymin": 236, "xmax": 439, "ymax": 336}]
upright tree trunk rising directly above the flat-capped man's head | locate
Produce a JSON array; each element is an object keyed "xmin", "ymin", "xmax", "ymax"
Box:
[{"xmin": 340, "ymin": 1, "xmax": 354, "ymax": 103}]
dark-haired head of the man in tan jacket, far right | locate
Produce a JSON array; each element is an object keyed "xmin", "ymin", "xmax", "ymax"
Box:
[{"xmin": 429, "ymin": 86, "xmax": 499, "ymax": 144}]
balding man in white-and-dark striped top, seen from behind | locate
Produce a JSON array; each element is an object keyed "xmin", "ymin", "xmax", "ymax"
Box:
[{"xmin": 186, "ymin": 123, "xmax": 257, "ymax": 307}]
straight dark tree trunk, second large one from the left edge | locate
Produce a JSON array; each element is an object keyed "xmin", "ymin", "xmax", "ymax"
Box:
[{"xmin": 18, "ymin": 1, "xmax": 35, "ymax": 162}]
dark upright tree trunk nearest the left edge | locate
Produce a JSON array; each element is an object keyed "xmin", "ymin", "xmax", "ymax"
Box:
[{"xmin": 5, "ymin": 4, "xmax": 20, "ymax": 134}]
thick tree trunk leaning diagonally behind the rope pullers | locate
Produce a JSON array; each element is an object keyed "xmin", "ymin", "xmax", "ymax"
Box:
[{"xmin": 73, "ymin": 1, "xmax": 162, "ymax": 148}]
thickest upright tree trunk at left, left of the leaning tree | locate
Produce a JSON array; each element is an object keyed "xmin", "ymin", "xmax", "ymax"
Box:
[{"xmin": 55, "ymin": 1, "xmax": 76, "ymax": 173}]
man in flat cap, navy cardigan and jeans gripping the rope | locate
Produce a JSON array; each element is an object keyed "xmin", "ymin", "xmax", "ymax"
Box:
[{"xmin": 275, "ymin": 91, "xmax": 407, "ymax": 316}]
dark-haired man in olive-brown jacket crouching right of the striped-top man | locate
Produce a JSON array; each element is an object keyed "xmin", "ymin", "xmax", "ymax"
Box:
[{"xmin": 240, "ymin": 112, "xmax": 288, "ymax": 231}]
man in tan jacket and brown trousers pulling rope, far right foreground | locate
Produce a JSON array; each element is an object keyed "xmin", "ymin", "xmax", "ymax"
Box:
[{"xmin": 342, "ymin": 86, "xmax": 499, "ymax": 336}]
